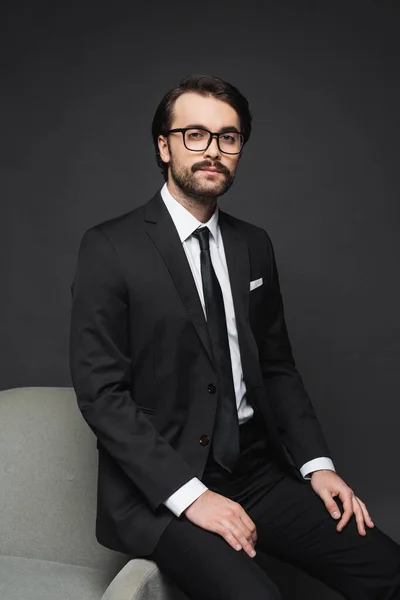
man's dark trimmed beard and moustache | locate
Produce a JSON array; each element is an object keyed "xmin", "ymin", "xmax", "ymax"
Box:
[{"xmin": 169, "ymin": 156, "xmax": 235, "ymax": 206}]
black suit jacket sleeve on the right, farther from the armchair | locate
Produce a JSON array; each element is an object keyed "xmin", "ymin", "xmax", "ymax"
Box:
[{"xmin": 260, "ymin": 231, "xmax": 330, "ymax": 469}]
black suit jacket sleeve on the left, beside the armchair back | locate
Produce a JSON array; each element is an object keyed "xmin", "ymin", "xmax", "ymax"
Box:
[{"xmin": 69, "ymin": 227, "xmax": 196, "ymax": 510}]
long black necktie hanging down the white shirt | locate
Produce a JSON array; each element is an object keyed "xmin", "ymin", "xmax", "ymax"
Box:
[{"xmin": 193, "ymin": 227, "xmax": 240, "ymax": 473}]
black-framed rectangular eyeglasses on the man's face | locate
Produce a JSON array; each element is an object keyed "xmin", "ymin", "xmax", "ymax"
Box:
[{"xmin": 167, "ymin": 127, "xmax": 244, "ymax": 154}]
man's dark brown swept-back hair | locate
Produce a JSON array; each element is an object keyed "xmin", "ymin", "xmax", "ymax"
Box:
[{"xmin": 151, "ymin": 74, "xmax": 252, "ymax": 181}]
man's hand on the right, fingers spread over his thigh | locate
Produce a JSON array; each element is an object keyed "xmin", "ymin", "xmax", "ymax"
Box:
[{"xmin": 311, "ymin": 469, "xmax": 374, "ymax": 535}]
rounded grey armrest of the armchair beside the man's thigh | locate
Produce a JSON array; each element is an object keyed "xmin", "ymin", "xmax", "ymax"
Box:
[{"xmin": 102, "ymin": 558, "xmax": 188, "ymax": 600}]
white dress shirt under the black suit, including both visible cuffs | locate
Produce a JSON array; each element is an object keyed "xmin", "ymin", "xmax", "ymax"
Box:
[{"xmin": 161, "ymin": 183, "xmax": 335, "ymax": 517}]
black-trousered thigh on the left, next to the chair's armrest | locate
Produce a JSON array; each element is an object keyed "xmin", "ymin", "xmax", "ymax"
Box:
[{"xmin": 147, "ymin": 517, "xmax": 281, "ymax": 600}]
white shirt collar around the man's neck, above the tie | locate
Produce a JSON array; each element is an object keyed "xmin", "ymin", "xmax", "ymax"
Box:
[{"xmin": 160, "ymin": 182, "xmax": 220, "ymax": 247}]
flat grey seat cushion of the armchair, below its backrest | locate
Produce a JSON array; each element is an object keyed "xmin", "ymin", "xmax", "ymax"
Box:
[{"xmin": 0, "ymin": 556, "xmax": 113, "ymax": 600}]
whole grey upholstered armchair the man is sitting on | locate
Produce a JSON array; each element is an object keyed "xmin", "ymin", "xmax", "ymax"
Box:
[{"xmin": 0, "ymin": 387, "xmax": 187, "ymax": 600}]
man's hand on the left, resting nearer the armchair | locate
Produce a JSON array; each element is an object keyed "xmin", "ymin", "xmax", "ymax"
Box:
[{"xmin": 184, "ymin": 490, "xmax": 257, "ymax": 558}]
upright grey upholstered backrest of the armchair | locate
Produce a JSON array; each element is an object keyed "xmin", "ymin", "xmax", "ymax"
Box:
[{"xmin": 0, "ymin": 387, "xmax": 127, "ymax": 571}]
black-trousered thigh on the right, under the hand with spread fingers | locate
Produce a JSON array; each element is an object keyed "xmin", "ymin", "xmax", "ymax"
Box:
[{"xmin": 244, "ymin": 476, "xmax": 400, "ymax": 600}]
